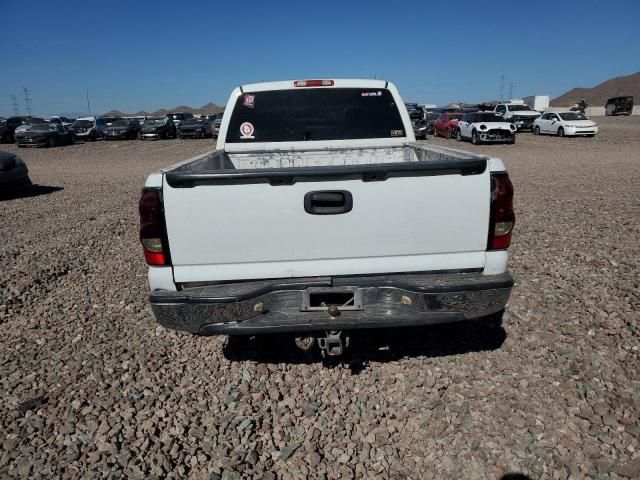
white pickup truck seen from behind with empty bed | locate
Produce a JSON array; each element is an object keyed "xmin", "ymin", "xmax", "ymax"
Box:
[{"xmin": 139, "ymin": 80, "xmax": 515, "ymax": 355}]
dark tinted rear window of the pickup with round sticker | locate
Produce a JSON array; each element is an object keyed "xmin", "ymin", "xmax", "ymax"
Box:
[{"xmin": 226, "ymin": 88, "xmax": 406, "ymax": 143}]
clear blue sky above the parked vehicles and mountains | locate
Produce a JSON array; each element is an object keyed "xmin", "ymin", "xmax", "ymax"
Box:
[{"xmin": 0, "ymin": 0, "xmax": 640, "ymax": 116}]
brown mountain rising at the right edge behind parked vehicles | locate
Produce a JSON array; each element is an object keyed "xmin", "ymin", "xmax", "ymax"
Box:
[{"xmin": 551, "ymin": 72, "xmax": 640, "ymax": 107}]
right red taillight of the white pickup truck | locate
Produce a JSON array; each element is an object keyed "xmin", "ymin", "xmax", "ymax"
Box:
[{"xmin": 487, "ymin": 173, "xmax": 516, "ymax": 250}]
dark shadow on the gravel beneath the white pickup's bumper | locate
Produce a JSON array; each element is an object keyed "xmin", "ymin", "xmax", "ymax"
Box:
[{"xmin": 223, "ymin": 321, "xmax": 507, "ymax": 374}]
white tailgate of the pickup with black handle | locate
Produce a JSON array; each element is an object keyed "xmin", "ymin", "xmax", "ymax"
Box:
[{"xmin": 163, "ymin": 152, "xmax": 490, "ymax": 283}]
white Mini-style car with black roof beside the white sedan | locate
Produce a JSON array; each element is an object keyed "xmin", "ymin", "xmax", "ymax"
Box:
[{"xmin": 456, "ymin": 112, "xmax": 517, "ymax": 145}]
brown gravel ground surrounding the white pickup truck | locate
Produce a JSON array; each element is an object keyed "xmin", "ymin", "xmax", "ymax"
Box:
[{"xmin": 0, "ymin": 118, "xmax": 640, "ymax": 479}]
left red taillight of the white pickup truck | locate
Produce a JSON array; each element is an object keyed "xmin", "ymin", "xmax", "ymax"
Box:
[{"xmin": 138, "ymin": 188, "xmax": 169, "ymax": 265}]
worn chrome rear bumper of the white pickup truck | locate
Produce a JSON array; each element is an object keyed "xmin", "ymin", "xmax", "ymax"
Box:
[{"xmin": 149, "ymin": 272, "xmax": 513, "ymax": 335}]
